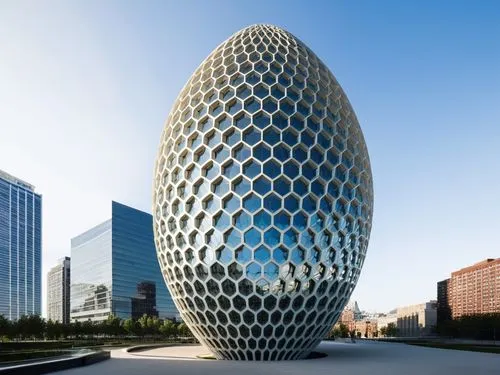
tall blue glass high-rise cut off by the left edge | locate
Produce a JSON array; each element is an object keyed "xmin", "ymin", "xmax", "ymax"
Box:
[{"xmin": 0, "ymin": 170, "xmax": 42, "ymax": 320}]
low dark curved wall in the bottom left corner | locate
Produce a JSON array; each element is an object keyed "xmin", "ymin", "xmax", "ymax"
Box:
[{"xmin": 0, "ymin": 351, "xmax": 110, "ymax": 375}]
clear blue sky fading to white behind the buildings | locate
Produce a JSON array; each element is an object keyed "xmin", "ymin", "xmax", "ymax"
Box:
[{"xmin": 0, "ymin": 0, "xmax": 500, "ymax": 311}]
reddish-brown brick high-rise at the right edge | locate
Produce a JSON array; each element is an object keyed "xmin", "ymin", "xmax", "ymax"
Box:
[{"xmin": 438, "ymin": 258, "xmax": 500, "ymax": 318}]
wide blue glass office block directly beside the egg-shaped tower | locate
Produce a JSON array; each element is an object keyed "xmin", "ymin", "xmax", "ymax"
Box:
[{"xmin": 70, "ymin": 202, "xmax": 179, "ymax": 321}]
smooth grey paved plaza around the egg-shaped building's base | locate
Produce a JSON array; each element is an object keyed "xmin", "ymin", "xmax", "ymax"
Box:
[{"xmin": 51, "ymin": 341, "xmax": 500, "ymax": 375}]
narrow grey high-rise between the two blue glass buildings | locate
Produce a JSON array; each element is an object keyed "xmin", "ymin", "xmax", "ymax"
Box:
[{"xmin": 47, "ymin": 257, "xmax": 71, "ymax": 324}]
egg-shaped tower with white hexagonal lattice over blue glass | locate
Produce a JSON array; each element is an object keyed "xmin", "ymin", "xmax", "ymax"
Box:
[{"xmin": 153, "ymin": 25, "xmax": 373, "ymax": 360}]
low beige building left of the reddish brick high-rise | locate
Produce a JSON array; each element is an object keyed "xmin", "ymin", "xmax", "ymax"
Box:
[{"xmin": 396, "ymin": 301, "xmax": 437, "ymax": 337}]
